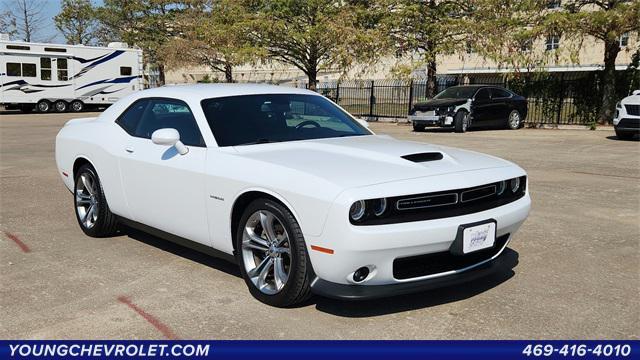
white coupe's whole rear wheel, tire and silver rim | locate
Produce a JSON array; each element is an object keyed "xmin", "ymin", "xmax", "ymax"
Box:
[{"xmin": 73, "ymin": 164, "xmax": 118, "ymax": 237}]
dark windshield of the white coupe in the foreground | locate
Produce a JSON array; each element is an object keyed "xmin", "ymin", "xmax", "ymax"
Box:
[{"xmin": 202, "ymin": 94, "xmax": 371, "ymax": 146}]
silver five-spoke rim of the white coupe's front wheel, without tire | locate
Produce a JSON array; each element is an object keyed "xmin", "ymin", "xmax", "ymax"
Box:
[{"xmin": 242, "ymin": 210, "xmax": 291, "ymax": 295}]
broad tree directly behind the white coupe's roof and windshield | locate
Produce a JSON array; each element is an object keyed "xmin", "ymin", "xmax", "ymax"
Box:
[{"xmin": 249, "ymin": 0, "xmax": 380, "ymax": 90}]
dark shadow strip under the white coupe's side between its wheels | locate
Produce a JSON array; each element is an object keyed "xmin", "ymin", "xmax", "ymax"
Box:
[{"xmin": 120, "ymin": 226, "xmax": 242, "ymax": 279}]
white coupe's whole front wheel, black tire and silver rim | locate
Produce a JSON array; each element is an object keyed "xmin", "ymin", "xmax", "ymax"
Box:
[{"xmin": 234, "ymin": 199, "xmax": 311, "ymax": 307}]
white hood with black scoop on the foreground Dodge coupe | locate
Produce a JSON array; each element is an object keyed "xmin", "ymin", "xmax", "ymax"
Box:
[{"xmin": 230, "ymin": 135, "xmax": 515, "ymax": 188}]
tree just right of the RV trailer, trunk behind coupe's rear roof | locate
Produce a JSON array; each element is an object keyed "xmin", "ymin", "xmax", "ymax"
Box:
[{"xmin": 96, "ymin": 0, "xmax": 188, "ymax": 84}]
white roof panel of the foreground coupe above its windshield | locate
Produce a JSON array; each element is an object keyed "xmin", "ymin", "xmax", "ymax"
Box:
[{"xmin": 136, "ymin": 84, "xmax": 318, "ymax": 101}]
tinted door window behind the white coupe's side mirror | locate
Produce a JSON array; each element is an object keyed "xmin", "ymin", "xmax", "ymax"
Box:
[{"xmin": 133, "ymin": 99, "xmax": 204, "ymax": 146}]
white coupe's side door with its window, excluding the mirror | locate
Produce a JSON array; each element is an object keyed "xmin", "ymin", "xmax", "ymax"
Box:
[{"xmin": 118, "ymin": 98, "xmax": 209, "ymax": 245}]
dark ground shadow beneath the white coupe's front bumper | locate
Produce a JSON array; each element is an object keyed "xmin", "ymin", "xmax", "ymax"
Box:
[{"xmin": 302, "ymin": 248, "xmax": 519, "ymax": 318}]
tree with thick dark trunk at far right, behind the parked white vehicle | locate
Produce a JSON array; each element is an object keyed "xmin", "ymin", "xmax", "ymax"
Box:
[{"xmin": 559, "ymin": 0, "xmax": 640, "ymax": 124}]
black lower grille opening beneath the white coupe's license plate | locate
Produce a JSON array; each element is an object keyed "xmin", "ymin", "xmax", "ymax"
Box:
[{"xmin": 393, "ymin": 234, "xmax": 509, "ymax": 280}]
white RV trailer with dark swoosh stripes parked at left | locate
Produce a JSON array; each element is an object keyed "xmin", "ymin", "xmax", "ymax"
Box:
[{"xmin": 0, "ymin": 35, "xmax": 143, "ymax": 112}]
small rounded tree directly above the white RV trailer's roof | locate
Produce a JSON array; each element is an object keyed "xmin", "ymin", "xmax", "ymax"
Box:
[{"xmin": 54, "ymin": 0, "xmax": 97, "ymax": 44}]
